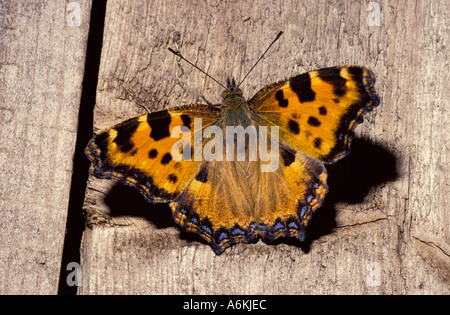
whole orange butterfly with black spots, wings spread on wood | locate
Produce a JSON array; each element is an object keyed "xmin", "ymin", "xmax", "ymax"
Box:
[{"xmin": 85, "ymin": 34, "xmax": 380, "ymax": 254}]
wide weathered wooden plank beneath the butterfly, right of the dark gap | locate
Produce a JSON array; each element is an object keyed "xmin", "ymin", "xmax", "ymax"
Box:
[{"xmin": 78, "ymin": 0, "xmax": 450, "ymax": 294}]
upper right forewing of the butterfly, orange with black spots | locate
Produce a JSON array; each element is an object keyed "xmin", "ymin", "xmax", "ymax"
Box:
[{"xmin": 248, "ymin": 66, "xmax": 379, "ymax": 163}]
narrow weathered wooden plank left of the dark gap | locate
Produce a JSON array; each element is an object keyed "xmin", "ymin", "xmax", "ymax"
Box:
[{"xmin": 0, "ymin": 0, "xmax": 91, "ymax": 294}]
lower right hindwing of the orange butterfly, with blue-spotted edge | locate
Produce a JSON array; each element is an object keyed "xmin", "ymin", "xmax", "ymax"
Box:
[{"xmin": 256, "ymin": 145, "xmax": 328, "ymax": 241}]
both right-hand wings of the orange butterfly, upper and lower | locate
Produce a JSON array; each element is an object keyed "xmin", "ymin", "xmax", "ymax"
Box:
[{"xmin": 239, "ymin": 66, "xmax": 379, "ymax": 248}]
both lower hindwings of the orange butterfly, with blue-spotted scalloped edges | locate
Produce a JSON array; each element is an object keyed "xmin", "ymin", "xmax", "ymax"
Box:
[{"xmin": 170, "ymin": 141, "xmax": 328, "ymax": 254}]
